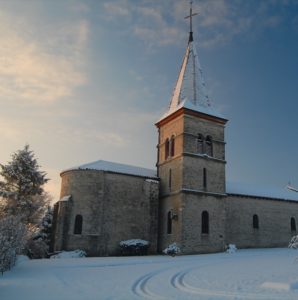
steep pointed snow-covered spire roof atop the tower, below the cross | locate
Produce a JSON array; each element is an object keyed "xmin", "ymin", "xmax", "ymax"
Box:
[{"xmin": 159, "ymin": 41, "xmax": 225, "ymax": 121}]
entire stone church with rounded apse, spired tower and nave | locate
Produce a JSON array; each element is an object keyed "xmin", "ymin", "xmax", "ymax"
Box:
[{"xmin": 53, "ymin": 10, "xmax": 298, "ymax": 256}]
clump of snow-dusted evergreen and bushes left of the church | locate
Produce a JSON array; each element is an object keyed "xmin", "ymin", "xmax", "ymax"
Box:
[{"xmin": 0, "ymin": 145, "xmax": 51, "ymax": 272}]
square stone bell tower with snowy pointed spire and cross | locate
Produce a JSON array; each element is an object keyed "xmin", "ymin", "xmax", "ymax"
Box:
[{"xmin": 156, "ymin": 2, "xmax": 227, "ymax": 254}]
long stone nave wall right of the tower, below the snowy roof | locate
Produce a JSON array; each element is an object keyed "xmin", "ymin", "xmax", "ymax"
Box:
[{"xmin": 225, "ymin": 195, "xmax": 298, "ymax": 248}]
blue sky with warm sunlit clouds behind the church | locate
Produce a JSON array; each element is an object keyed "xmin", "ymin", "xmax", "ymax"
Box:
[{"xmin": 0, "ymin": 0, "xmax": 298, "ymax": 201}]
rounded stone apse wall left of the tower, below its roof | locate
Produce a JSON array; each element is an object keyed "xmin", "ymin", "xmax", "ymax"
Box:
[{"xmin": 55, "ymin": 170, "xmax": 159, "ymax": 256}]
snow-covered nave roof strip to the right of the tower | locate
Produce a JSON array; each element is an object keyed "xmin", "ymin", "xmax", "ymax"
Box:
[{"xmin": 226, "ymin": 182, "xmax": 298, "ymax": 201}]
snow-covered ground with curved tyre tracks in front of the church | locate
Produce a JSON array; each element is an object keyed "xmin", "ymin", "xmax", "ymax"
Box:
[{"xmin": 0, "ymin": 249, "xmax": 298, "ymax": 300}]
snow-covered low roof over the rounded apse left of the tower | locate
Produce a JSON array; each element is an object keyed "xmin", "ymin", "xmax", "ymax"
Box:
[{"xmin": 62, "ymin": 160, "xmax": 157, "ymax": 178}]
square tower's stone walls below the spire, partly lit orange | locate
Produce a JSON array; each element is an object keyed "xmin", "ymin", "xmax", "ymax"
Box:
[{"xmin": 158, "ymin": 113, "xmax": 226, "ymax": 254}]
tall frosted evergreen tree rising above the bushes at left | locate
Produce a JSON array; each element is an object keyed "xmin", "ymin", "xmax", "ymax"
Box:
[{"xmin": 0, "ymin": 145, "xmax": 48, "ymax": 224}]
